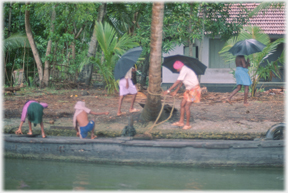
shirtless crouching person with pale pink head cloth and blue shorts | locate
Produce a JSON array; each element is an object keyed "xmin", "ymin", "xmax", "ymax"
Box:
[{"xmin": 73, "ymin": 101, "xmax": 109, "ymax": 139}]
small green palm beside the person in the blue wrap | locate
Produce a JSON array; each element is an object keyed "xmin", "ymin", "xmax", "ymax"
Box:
[{"xmin": 219, "ymin": 26, "xmax": 284, "ymax": 97}]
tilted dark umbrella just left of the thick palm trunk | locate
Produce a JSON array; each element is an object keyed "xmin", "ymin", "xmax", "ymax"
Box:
[{"xmin": 114, "ymin": 47, "xmax": 142, "ymax": 80}]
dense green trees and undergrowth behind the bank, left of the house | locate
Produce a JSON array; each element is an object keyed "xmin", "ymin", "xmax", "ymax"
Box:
[{"xmin": 3, "ymin": 2, "xmax": 247, "ymax": 91}]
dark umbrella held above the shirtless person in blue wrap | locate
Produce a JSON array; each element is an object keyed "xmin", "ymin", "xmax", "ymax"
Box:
[{"xmin": 228, "ymin": 39, "xmax": 266, "ymax": 56}]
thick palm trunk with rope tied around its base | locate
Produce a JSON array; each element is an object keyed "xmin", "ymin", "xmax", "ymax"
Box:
[{"xmin": 140, "ymin": 2, "xmax": 164, "ymax": 121}]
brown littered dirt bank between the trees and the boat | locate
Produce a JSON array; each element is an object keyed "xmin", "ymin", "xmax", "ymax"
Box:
[{"xmin": 2, "ymin": 88, "xmax": 285, "ymax": 139}]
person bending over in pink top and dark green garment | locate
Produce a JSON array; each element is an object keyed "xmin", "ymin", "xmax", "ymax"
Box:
[{"xmin": 15, "ymin": 100, "xmax": 48, "ymax": 138}]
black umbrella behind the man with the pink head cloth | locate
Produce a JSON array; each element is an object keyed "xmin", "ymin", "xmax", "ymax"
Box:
[{"xmin": 162, "ymin": 55, "xmax": 207, "ymax": 75}]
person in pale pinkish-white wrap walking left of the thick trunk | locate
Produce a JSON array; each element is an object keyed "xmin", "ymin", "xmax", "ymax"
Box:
[{"xmin": 117, "ymin": 67, "xmax": 140, "ymax": 116}]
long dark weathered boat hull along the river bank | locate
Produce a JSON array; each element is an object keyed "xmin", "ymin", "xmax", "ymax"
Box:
[{"xmin": 4, "ymin": 135, "xmax": 285, "ymax": 167}]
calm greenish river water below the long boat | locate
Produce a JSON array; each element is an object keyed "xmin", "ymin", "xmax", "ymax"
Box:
[{"xmin": 2, "ymin": 158, "xmax": 285, "ymax": 191}]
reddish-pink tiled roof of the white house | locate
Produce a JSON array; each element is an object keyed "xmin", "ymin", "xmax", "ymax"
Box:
[{"xmin": 229, "ymin": 3, "xmax": 286, "ymax": 35}]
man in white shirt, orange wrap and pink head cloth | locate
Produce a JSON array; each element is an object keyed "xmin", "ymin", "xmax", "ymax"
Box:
[{"xmin": 164, "ymin": 61, "xmax": 201, "ymax": 129}]
